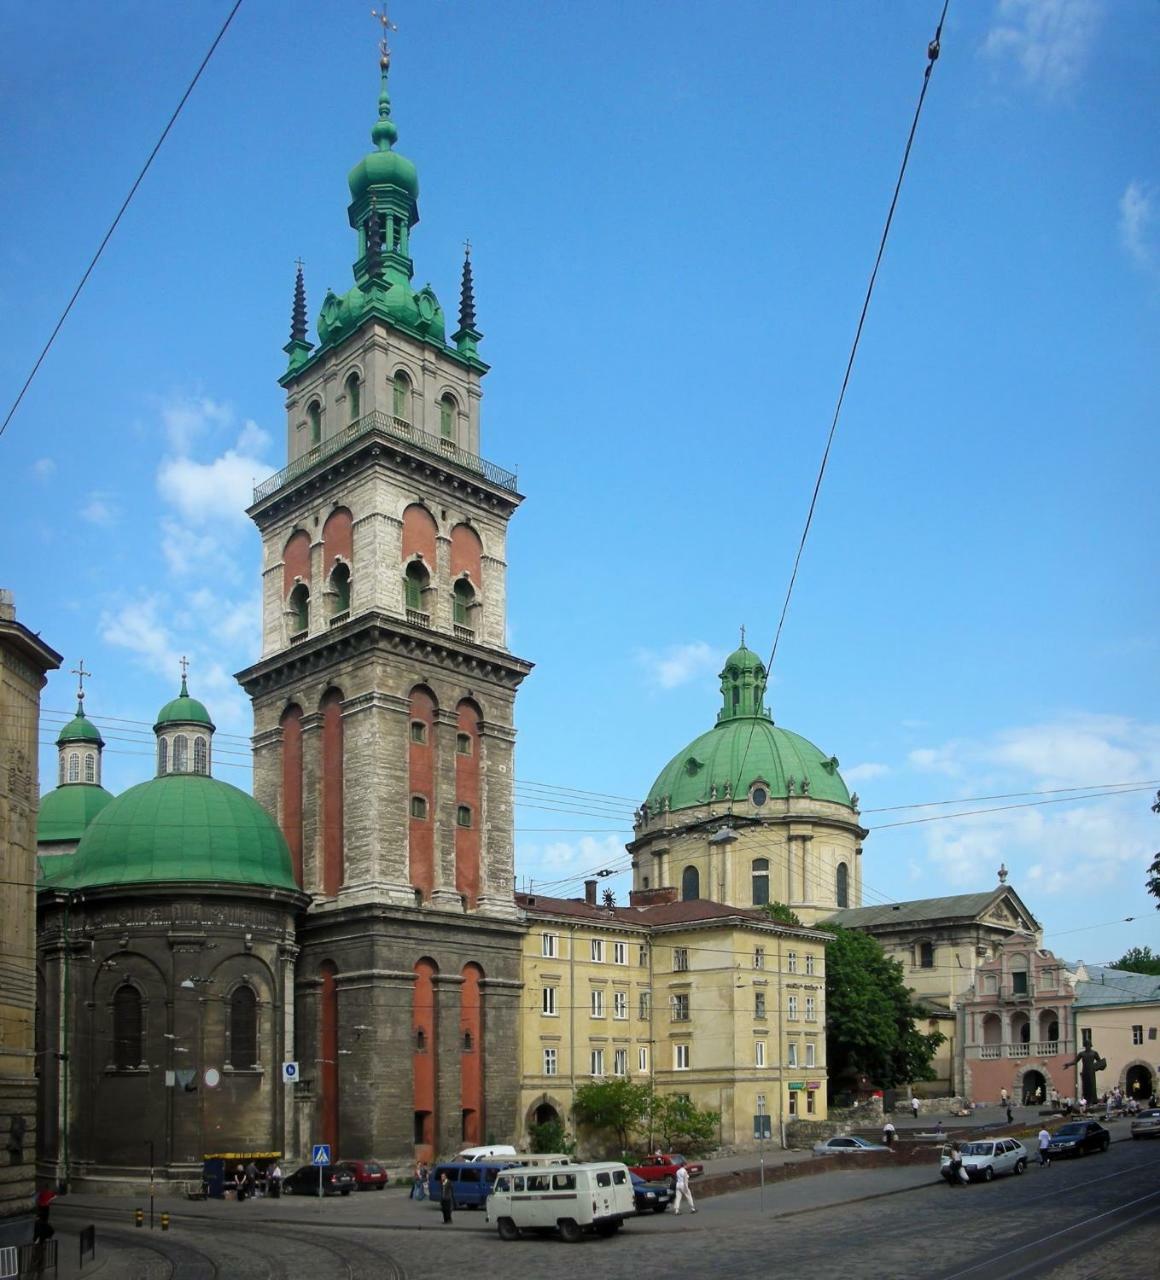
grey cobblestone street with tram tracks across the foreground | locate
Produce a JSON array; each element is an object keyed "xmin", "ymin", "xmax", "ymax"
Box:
[{"xmin": 60, "ymin": 1142, "xmax": 1160, "ymax": 1280}]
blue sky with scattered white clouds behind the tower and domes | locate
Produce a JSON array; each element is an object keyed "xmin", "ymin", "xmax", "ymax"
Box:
[{"xmin": 0, "ymin": 0, "xmax": 1160, "ymax": 961}]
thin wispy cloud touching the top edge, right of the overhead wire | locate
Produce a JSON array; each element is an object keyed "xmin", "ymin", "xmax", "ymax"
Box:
[{"xmin": 983, "ymin": 0, "xmax": 1100, "ymax": 95}]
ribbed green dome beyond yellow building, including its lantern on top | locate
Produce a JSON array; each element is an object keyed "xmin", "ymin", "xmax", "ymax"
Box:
[{"xmin": 645, "ymin": 644, "xmax": 851, "ymax": 813}]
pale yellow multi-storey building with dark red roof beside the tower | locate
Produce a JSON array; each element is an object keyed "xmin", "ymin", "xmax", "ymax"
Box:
[{"xmin": 516, "ymin": 881, "xmax": 827, "ymax": 1148}]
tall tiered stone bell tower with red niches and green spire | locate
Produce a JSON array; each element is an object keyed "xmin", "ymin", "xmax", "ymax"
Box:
[{"xmin": 238, "ymin": 40, "xmax": 531, "ymax": 1160}]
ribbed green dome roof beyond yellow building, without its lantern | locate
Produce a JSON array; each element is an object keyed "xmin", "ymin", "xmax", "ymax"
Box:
[{"xmin": 647, "ymin": 716, "xmax": 850, "ymax": 810}]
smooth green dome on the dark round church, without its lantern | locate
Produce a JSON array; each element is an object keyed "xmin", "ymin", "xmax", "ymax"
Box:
[{"xmin": 52, "ymin": 773, "xmax": 298, "ymax": 890}]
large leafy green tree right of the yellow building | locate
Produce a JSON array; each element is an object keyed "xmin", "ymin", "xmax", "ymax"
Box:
[{"xmin": 819, "ymin": 924, "xmax": 946, "ymax": 1089}]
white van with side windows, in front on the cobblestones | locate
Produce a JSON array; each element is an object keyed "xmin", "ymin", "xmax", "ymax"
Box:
[{"xmin": 487, "ymin": 1162, "xmax": 636, "ymax": 1244}]
